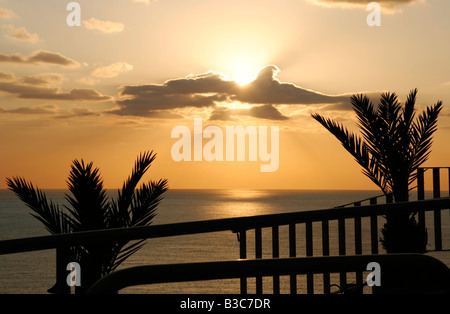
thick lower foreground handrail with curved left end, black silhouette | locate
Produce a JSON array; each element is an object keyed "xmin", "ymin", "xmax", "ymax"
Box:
[{"xmin": 87, "ymin": 253, "xmax": 450, "ymax": 294}]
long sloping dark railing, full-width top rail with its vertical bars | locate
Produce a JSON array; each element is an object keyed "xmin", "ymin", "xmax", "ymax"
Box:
[{"xmin": 0, "ymin": 198, "xmax": 450, "ymax": 294}]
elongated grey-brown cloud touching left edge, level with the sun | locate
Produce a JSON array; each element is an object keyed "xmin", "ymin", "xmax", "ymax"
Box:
[{"xmin": 0, "ymin": 50, "xmax": 80, "ymax": 68}]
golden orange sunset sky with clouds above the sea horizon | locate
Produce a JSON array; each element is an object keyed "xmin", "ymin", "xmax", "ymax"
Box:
[{"xmin": 0, "ymin": 0, "xmax": 450, "ymax": 190}]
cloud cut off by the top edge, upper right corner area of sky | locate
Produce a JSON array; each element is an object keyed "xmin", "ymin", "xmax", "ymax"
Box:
[{"xmin": 308, "ymin": 0, "xmax": 425, "ymax": 13}]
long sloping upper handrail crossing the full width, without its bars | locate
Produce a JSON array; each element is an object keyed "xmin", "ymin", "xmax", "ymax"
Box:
[{"xmin": 0, "ymin": 197, "xmax": 450, "ymax": 255}]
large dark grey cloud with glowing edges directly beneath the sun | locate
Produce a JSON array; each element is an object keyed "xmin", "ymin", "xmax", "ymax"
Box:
[{"xmin": 111, "ymin": 65, "xmax": 350, "ymax": 120}]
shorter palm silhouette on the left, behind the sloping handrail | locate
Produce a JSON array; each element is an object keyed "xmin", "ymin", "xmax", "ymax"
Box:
[{"xmin": 6, "ymin": 151, "xmax": 168, "ymax": 293}]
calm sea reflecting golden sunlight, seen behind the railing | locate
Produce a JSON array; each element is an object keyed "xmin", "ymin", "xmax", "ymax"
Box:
[{"xmin": 0, "ymin": 190, "xmax": 450, "ymax": 294}]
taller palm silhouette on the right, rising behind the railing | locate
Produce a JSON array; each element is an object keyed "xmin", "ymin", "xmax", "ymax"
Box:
[{"xmin": 312, "ymin": 89, "xmax": 442, "ymax": 252}]
